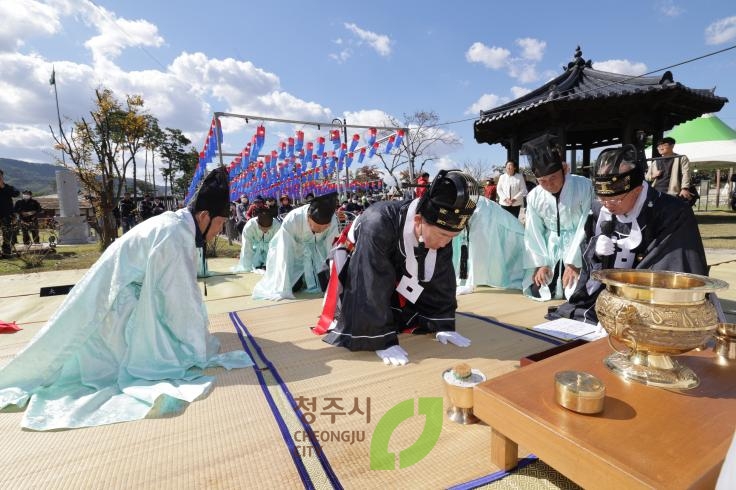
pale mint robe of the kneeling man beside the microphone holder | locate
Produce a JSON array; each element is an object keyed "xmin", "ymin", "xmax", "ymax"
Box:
[{"xmin": 522, "ymin": 174, "xmax": 593, "ymax": 301}]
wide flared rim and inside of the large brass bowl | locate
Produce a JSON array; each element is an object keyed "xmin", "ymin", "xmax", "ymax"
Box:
[{"xmin": 592, "ymin": 269, "xmax": 728, "ymax": 304}]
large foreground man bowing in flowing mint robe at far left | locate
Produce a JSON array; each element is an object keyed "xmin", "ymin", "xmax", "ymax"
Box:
[{"xmin": 0, "ymin": 167, "xmax": 252, "ymax": 430}]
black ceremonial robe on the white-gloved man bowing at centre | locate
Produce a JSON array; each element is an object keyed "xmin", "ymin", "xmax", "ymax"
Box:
[{"xmin": 324, "ymin": 199, "xmax": 457, "ymax": 351}]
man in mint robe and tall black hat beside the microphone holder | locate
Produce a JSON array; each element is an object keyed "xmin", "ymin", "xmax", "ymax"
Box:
[{"xmin": 522, "ymin": 135, "xmax": 593, "ymax": 301}]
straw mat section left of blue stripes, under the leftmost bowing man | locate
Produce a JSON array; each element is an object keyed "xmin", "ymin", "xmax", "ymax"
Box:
[{"xmin": 0, "ymin": 317, "xmax": 302, "ymax": 489}]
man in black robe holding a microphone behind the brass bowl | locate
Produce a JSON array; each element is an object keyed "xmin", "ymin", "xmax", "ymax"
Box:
[{"xmin": 548, "ymin": 145, "xmax": 708, "ymax": 324}]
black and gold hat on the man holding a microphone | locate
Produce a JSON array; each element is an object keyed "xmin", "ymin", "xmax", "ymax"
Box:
[{"xmin": 593, "ymin": 145, "xmax": 645, "ymax": 196}]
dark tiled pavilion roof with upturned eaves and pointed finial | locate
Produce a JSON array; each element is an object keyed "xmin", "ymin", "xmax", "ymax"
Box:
[{"xmin": 473, "ymin": 46, "xmax": 728, "ymax": 171}]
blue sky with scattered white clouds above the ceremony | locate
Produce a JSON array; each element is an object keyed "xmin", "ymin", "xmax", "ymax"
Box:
[{"xmin": 0, "ymin": 0, "xmax": 736, "ymax": 183}]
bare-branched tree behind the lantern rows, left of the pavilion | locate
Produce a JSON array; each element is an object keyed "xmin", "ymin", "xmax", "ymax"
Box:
[{"xmin": 376, "ymin": 111, "xmax": 460, "ymax": 188}]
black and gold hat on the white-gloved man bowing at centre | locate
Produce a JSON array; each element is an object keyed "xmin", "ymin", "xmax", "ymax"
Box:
[{"xmin": 417, "ymin": 170, "xmax": 480, "ymax": 231}]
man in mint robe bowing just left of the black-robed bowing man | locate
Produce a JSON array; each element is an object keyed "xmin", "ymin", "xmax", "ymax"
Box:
[{"xmin": 253, "ymin": 192, "xmax": 339, "ymax": 301}]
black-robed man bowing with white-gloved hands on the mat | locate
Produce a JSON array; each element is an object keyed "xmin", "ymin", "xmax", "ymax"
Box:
[{"xmin": 315, "ymin": 170, "xmax": 479, "ymax": 365}]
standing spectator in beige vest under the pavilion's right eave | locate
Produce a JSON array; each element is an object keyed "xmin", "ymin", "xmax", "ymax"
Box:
[{"xmin": 646, "ymin": 137, "xmax": 692, "ymax": 201}]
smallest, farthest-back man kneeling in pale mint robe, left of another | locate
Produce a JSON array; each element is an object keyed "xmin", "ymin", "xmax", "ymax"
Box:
[{"xmin": 232, "ymin": 203, "xmax": 281, "ymax": 272}]
